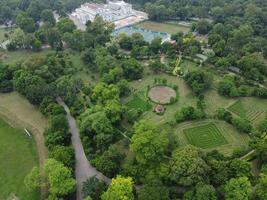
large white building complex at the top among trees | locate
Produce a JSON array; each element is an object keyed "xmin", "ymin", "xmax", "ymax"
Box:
[{"xmin": 70, "ymin": 0, "xmax": 147, "ymax": 27}]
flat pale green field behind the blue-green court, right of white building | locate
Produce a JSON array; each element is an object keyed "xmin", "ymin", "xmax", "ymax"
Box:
[{"xmin": 136, "ymin": 21, "xmax": 190, "ymax": 34}]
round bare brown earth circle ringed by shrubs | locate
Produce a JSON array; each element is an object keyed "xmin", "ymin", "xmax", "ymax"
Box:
[{"xmin": 147, "ymin": 86, "xmax": 176, "ymax": 104}]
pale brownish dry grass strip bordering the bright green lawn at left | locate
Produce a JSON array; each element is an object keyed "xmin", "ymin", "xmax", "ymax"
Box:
[{"xmin": 0, "ymin": 92, "xmax": 47, "ymax": 166}]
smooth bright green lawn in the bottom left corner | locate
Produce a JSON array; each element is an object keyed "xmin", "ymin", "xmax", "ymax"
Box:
[{"xmin": 0, "ymin": 119, "xmax": 40, "ymax": 200}]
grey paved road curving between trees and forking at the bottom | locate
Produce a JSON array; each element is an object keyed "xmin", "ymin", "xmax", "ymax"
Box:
[{"xmin": 57, "ymin": 98, "xmax": 111, "ymax": 200}]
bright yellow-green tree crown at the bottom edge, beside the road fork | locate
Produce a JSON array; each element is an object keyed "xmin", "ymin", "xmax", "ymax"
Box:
[{"xmin": 101, "ymin": 176, "xmax": 134, "ymax": 200}]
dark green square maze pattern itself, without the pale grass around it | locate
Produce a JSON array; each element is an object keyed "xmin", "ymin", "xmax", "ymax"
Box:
[{"xmin": 184, "ymin": 123, "xmax": 227, "ymax": 149}]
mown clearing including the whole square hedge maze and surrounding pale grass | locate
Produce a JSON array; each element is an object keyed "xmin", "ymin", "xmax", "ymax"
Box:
[{"xmin": 175, "ymin": 119, "xmax": 249, "ymax": 155}]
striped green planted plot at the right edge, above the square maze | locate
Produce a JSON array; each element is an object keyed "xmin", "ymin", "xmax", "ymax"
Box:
[{"xmin": 227, "ymin": 97, "xmax": 267, "ymax": 123}]
